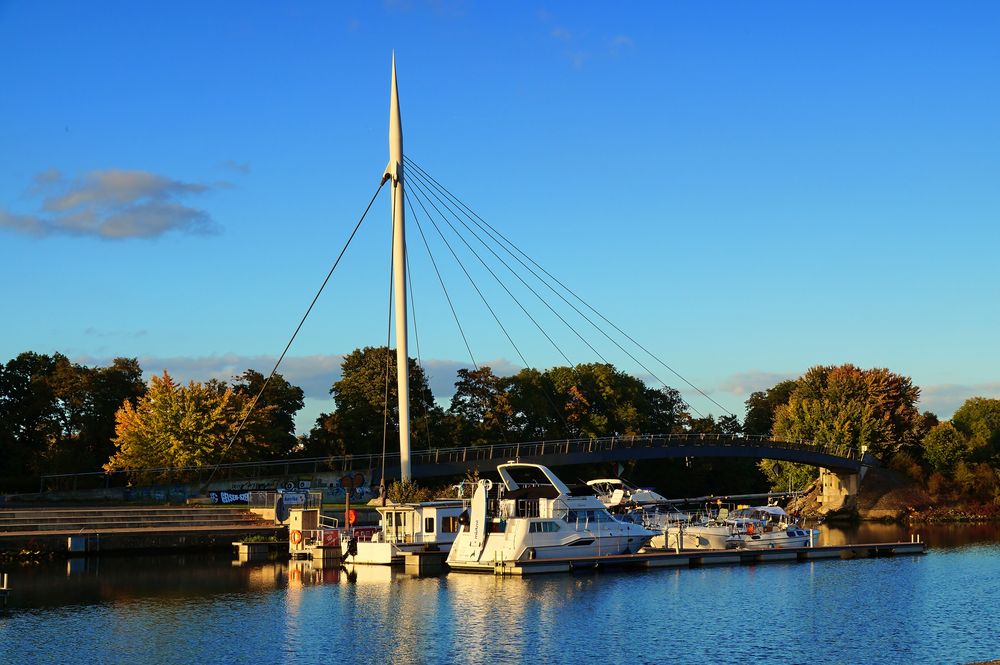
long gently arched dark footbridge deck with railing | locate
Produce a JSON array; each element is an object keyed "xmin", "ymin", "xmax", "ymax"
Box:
[{"xmin": 39, "ymin": 433, "xmax": 858, "ymax": 492}]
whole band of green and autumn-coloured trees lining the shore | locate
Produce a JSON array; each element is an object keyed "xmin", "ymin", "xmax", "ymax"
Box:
[{"xmin": 0, "ymin": 347, "xmax": 1000, "ymax": 522}]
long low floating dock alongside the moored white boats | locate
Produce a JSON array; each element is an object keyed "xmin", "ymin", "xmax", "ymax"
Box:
[{"xmin": 493, "ymin": 542, "xmax": 925, "ymax": 575}]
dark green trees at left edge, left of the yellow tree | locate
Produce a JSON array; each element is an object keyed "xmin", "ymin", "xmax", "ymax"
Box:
[{"xmin": 0, "ymin": 352, "xmax": 145, "ymax": 476}]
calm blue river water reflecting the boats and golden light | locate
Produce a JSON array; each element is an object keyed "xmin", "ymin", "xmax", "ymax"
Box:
[{"xmin": 0, "ymin": 525, "xmax": 1000, "ymax": 665}]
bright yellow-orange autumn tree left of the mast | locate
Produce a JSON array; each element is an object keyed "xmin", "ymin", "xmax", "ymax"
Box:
[{"xmin": 104, "ymin": 372, "xmax": 267, "ymax": 480}]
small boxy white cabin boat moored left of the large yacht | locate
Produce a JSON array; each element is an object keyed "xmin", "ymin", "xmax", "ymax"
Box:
[{"xmin": 341, "ymin": 499, "xmax": 465, "ymax": 565}]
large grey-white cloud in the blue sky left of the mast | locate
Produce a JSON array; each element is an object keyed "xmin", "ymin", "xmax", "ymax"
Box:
[{"xmin": 0, "ymin": 169, "xmax": 224, "ymax": 240}]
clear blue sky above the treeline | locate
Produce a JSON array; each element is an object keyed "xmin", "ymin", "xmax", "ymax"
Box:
[{"xmin": 0, "ymin": 0, "xmax": 1000, "ymax": 426}]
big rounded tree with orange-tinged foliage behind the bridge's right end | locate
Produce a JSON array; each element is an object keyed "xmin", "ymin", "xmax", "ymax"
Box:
[{"xmin": 774, "ymin": 364, "xmax": 923, "ymax": 456}]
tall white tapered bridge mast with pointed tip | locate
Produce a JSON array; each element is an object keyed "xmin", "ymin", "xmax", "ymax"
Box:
[{"xmin": 383, "ymin": 53, "xmax": 410, "ymax": 481}]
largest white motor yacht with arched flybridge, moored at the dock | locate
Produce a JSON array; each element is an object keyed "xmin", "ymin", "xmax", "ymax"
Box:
[{"xmin": 447, "ymin": 462, "xmax": 656, "ymax": 570}]
